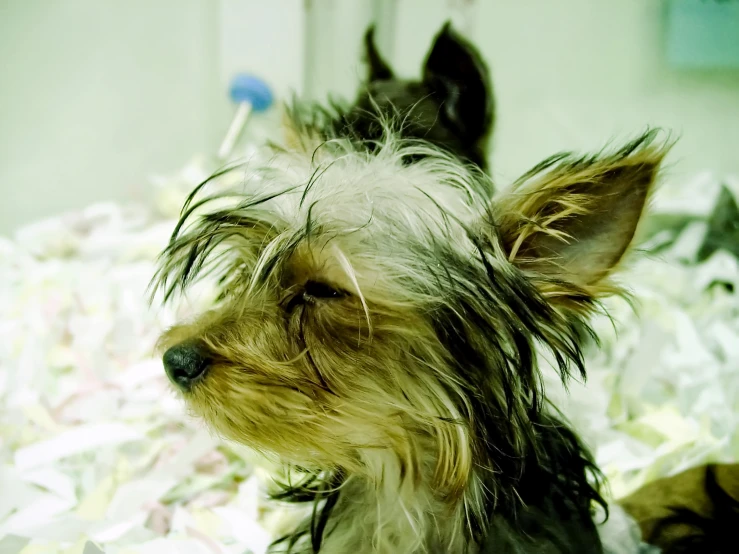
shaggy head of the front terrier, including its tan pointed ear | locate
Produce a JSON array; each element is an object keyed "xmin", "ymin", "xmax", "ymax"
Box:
[{"xmin": 156, "ymin": 130, "xmax": 665, "ymax": 494}]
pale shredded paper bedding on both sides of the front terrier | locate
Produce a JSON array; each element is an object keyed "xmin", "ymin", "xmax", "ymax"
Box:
[{"xmin": 0, "ymin": 157, "xmax": 739, "ymax": 554}]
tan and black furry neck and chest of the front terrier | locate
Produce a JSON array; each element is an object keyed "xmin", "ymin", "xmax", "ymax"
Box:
[{"xmin": 276, "ymin": 412, "xmax": 602, "ymax": 554}]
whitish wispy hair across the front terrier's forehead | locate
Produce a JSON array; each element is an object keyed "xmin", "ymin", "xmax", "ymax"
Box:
[{"xmin": 153, "ymin": 119, "xmax": 492, "ymax": 299}]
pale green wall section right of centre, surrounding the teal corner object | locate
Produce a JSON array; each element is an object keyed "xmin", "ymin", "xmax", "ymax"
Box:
[{"xmin": 394, "ymin": 0, "xmax": 739, "ymax": 183}]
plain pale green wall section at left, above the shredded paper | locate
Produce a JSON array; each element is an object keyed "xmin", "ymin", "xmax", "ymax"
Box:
[{"xmin": 0, "ymin": 0, "xmax": 220, "ymax": 232}]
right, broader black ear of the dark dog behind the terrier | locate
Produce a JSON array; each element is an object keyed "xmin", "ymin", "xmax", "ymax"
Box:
[{"xmin": 423, "ymin": 23, "xmax": 494, "ymax": 146}]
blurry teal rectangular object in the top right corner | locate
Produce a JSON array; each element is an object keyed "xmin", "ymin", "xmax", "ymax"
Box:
[{"xmin": 666, "ymin": 0, "xmax": 739, "ymax": 69}]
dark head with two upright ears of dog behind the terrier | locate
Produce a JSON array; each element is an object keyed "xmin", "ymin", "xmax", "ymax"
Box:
[{"xmin": 341, "ymin": 24, "xmax": 494, "ymax": 168}]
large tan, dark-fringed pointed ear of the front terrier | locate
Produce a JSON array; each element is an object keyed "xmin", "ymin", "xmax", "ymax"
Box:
[{"xmin": 493, "ymin": 131, "xmax": 671, "ymax": 302}]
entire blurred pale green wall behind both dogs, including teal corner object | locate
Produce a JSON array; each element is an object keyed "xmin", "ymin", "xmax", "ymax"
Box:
[{"xmin": 0, "ymin": 0, "xmax": 739, "ymax": 233}]
